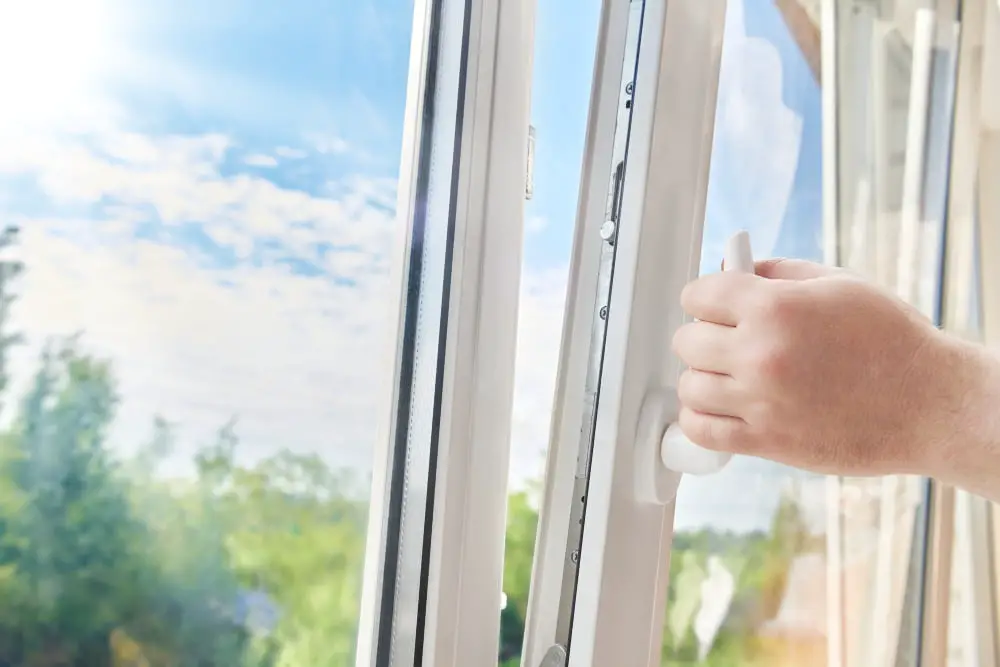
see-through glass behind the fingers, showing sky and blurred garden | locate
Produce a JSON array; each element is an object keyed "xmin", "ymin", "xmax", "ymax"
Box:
[{"xmin": 663, "ymin": 0, "xmax": 827, "ymax": 667}]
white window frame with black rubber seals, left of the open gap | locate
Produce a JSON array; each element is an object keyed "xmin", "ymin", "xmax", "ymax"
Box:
[{"xmin": 356, "ymin": 0, "xmax": 534, "ymax": 667}]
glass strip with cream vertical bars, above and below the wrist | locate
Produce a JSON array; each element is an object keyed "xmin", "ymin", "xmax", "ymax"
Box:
[{"xmin": 836, "ymin": 0, "xmax": 958, "ymax": 667}]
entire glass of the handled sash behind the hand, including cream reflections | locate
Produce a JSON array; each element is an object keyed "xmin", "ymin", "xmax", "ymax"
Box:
[{"xmin": 664, "ymin": 0, "xmax": 955, "ymax": 667}]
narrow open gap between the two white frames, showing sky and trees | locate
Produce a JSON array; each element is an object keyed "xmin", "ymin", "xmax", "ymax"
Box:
[{"xmin": 500, "ymin": 0, "xmax": 601, "ymax": 667}]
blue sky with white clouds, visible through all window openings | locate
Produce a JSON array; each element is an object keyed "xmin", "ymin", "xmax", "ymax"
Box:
[{"xmin": 0, "ymin": 0, "xmax": 821, "ymax": 526}]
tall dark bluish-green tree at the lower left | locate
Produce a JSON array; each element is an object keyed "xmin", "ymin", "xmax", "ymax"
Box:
[{"xmin": 0, "ymin": 338, "xmax": 144, "ymax": 664}]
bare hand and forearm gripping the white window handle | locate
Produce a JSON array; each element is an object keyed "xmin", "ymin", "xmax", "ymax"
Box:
[{"xmin": 674, "ymin": 260, "xmax": 1000, "ymax": 501}]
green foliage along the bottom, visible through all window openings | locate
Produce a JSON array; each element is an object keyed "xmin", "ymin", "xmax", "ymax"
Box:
[{"xmin": 0, "ymin": 229, "xmax": 812, "ymax": 667}]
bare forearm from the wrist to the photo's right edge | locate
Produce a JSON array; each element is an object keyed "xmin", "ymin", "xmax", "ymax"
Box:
[{"xmin": 926, "ymin": 341, "xmax": 1000, "ymax": 502}]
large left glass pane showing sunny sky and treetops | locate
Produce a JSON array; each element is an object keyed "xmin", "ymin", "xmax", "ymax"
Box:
[{"xmin": 0, "ymin": 0, "xmax": 412, "ymax": 667}]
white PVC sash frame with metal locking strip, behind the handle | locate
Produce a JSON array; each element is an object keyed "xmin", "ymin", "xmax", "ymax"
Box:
[{"xmin": 524, "ymin": 0, "xmax": 726, "ymax": 667}]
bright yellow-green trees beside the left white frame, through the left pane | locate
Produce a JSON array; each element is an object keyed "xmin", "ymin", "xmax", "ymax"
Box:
[{"xmin": 188, "ymin": 422, "xmax": 367, "ymax": 667}]
